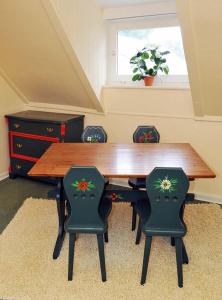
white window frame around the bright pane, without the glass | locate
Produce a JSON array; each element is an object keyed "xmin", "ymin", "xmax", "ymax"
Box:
[{"xmin": 107, "ymin": 13, "xmax": 190, "ymax": 88}]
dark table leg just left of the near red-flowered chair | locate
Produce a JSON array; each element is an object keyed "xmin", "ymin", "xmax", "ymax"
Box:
[{"xmin": 53, "ymin": 178, "xmax": 65, "ymax": 259}]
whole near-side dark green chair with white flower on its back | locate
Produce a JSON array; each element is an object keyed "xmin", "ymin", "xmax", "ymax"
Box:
[{"xmin": 135, "ymin": 168, "xmax": 189, "ymax": 287}]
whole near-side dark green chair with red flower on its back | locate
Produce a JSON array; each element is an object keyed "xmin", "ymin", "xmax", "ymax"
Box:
[{"xmin": 64, "ymin": 166, "xmax": 112, "ymax": 281}]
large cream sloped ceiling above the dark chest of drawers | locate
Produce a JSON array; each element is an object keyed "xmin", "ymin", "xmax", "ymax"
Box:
[{"xmin": 0, "ymin": 0, "xmax": 102, "ymax": 111}]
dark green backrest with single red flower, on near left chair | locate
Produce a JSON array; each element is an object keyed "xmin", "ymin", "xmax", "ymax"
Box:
[{"xmin": 63, "ymin": 166, "xmax": 105, "ymax": 232}]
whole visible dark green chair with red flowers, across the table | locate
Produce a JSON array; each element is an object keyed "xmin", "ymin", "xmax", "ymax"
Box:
[{"xmin": 128, "ymin": 126, "xmax": 160, "ymax": 231}]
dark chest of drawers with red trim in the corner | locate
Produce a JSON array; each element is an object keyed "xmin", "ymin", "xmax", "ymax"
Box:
[{"xmin": 6, "ymin": 110, "xmax": 84, "ymax": 183}]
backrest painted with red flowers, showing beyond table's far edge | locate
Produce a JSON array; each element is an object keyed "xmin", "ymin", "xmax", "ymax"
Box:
[{"xmin": 133, "ymin": 126, "xmax": 160, "ymax": 143}]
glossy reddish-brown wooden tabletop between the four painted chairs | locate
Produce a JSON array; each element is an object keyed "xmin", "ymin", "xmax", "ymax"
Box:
[{"xmin": 28, "ymin": 143, "xmax": 215, "ymax": 179}]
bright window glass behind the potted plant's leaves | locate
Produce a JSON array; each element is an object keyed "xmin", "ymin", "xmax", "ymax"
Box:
[{"xmin": 117, "ymin": 26, "xmax": 187, "ymax": 75}]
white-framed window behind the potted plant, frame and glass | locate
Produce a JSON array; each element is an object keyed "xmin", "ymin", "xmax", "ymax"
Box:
[{"xmin": 108, "ymin": 15, "xmax": 189, "ymax": 87}]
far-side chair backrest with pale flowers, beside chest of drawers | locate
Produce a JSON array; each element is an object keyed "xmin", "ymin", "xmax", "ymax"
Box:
[{"xmin": 82, "ymin": 126, "xmax": 107, "ymax": 143}]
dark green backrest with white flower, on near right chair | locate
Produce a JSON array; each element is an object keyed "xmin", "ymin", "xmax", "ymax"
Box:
[{"xmin": 145, "ymin": 168, "xmax": 189, "ymax": 235}]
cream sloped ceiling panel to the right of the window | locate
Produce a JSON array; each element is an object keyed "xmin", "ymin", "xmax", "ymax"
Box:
[{"xmin": 177, "ymin": 0, "xmax": 222, "ymax": 116}]
